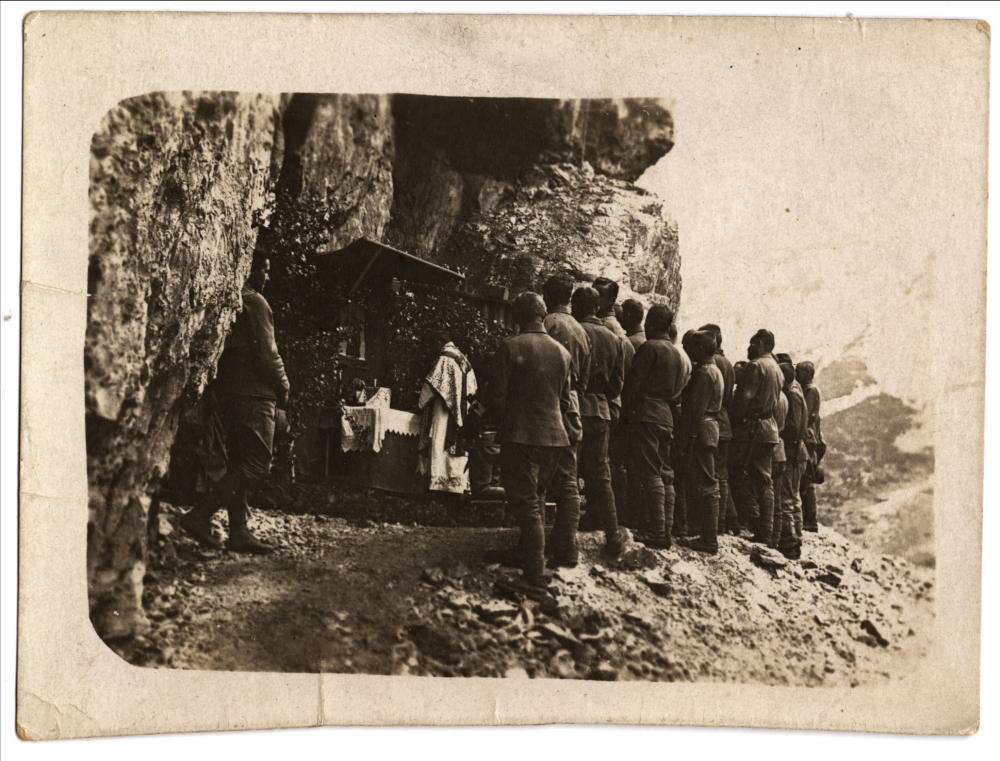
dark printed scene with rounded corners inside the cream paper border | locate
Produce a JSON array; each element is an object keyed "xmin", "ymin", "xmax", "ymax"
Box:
[{"xmin": 85, "ymin": 87, "xmax": 936, "ymax": 687}]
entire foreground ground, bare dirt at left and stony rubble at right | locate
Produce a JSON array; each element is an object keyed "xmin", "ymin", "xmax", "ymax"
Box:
[{"xmin": 118, "ymin": 498, "xmax": 933, "ymax": 685}]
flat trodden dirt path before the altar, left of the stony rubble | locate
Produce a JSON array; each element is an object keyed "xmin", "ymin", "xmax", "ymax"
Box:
[{"xmin": 138, "ymin": 511, "xmax": 512, "ymax": 674}]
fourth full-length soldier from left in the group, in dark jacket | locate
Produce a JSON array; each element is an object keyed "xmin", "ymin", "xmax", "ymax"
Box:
[{"xmin": 622, "ymin": 306, "xmax": 688, "ymax": 548}]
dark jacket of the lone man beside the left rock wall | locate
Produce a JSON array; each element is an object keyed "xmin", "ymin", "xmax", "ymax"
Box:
[{"xmin": 214, "ymin": 285, "xmax": 288, "ymax": 399}]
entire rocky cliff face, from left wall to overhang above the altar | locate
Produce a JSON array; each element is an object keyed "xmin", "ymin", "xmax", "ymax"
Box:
[{"xmin": 85, "ymin": 93, "xmax": 680, "ymax": 639}]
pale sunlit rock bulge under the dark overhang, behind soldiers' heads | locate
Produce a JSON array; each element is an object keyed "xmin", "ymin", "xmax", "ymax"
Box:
[{"xmin": 436, "ymin": 163, "xmax": 681, "ymax": 311}]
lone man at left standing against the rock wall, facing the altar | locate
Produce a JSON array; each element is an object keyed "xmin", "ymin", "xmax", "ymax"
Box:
[{"xmin": 181, "ymin": 258, "xmax": 289, "ymax": 555}]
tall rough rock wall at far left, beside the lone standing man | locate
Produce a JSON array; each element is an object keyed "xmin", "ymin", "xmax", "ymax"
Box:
[{"xmin": 84, "ymin": 93, "xmax": 282, "ymax": 639}]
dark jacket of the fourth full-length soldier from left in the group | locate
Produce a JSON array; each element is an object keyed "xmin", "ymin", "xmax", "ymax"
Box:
[{"xmin": 622, "ymin": 338, "xmax": 690, "ymax": 428}]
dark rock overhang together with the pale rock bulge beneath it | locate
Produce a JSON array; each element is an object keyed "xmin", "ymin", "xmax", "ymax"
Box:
[{"xmin": 386, "ymin": 96, "xmax": 680, "ymax": 309}]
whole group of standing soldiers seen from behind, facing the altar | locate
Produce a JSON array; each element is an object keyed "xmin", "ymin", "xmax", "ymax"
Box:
[{"xmin": 487, "ymin": 275, "xmax": 822, "ymax": 587}]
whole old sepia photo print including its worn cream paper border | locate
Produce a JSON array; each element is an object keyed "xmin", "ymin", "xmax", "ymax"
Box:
[{"xmin": 18, "ymin": 8, "xmax": 989, "ymax": 738}]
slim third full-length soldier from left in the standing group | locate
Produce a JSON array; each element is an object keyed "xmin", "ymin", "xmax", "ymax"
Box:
[{"xmin": 572, "ymin": 287, "xmax": 627, "ymax": 555}]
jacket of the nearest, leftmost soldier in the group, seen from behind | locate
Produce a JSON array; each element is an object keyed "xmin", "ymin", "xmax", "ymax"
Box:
[{"xmin": 491, "ymin": 326, "xmax": 573, "ymax": 447}]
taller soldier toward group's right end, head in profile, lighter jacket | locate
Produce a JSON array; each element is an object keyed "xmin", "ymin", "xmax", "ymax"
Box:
[{"xmin": 731, "ymin": 329, "xmax": 782, "ymax": 544}]
